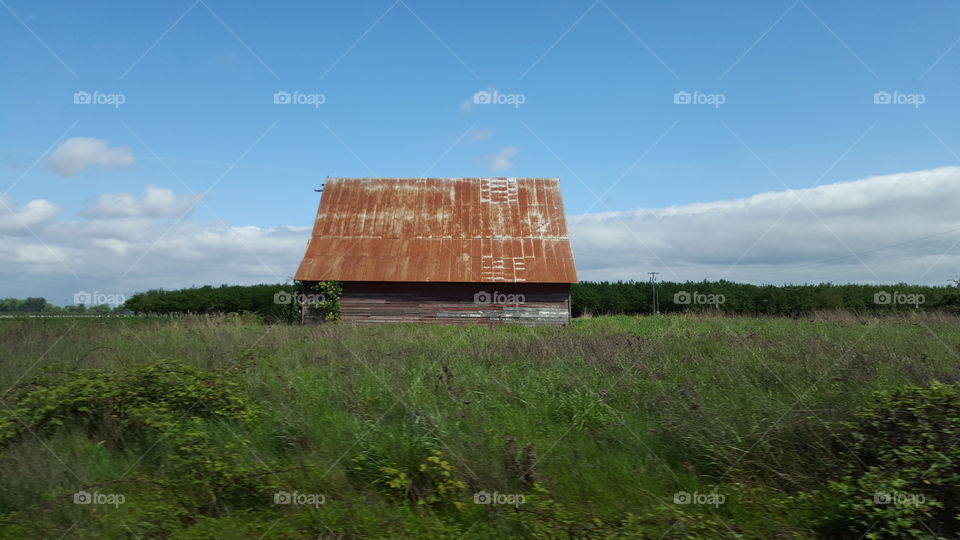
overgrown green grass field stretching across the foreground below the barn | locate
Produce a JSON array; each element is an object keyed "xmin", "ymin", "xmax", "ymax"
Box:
[{"xmin": 0, "ymin": 315, "xmax": 960, "ymax": 538}]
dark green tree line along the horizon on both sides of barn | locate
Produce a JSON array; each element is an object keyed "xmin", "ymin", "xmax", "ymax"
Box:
[{"xmin": 7, "ymin": 280, "xmax": 960, "ymax": 321}]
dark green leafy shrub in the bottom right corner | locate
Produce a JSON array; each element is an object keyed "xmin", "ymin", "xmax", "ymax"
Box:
[{"xmin": 823, "ymin": 383, "xmax": 960, "ymax": 539}]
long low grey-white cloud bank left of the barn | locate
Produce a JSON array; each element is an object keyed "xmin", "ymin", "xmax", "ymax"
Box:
[{"xmin": 0, "ymin": 207, "xmax": 310, "ymax": 304}]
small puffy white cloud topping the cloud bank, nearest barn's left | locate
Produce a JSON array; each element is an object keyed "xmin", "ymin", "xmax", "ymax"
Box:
[{"xmin": 84, "ymin": 185, "xmax": 203, "ymax": 219}]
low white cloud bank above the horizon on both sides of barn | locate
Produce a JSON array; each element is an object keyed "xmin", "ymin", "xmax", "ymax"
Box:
[{"xmin": 0, "ymin": 167, "xmax": 960, "ymax": 304}]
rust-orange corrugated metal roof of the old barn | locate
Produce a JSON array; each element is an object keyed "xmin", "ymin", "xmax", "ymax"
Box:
[{"xmin": 296, "ymin": 178, "xmax": 577, "ymax": 283}]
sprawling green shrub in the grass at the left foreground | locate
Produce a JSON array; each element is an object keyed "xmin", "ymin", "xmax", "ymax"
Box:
[{"xmin": 0, "ymin": 362, "xmax": 273, "ymax": 523}]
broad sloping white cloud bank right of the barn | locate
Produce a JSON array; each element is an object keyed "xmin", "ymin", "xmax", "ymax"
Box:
[{"xmin": 568, "ymin": 167, "xmax": 960, "ymax": 284}]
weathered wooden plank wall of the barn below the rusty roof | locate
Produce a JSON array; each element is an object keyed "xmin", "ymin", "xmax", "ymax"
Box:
[{"xmin": 304, "ymin": 282, "xmax": 570, "ymax": 325}]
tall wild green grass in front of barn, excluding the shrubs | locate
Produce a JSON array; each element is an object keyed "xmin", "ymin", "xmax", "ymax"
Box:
[{"xmin": 0, "ymin": 315, "xmax": 960, "ymax": 538}]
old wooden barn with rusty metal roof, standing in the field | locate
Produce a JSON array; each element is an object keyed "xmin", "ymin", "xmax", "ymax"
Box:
[{"xmin": 295, "ymin": 178, "xmax": 577, "ymax": 325}]
